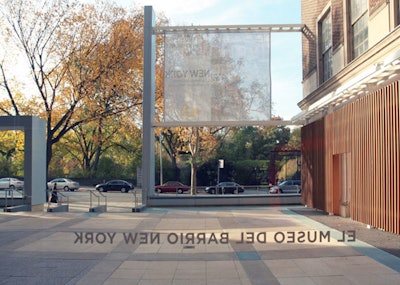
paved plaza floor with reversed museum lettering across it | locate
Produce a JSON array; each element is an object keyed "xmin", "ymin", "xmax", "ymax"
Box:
[{"xmin": 0, "ymin": 206, "xmax": 400, "ymax": 285}]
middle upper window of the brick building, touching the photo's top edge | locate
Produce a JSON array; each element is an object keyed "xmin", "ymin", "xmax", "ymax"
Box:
[{"xmin": 350, "ymin": 0, "xmax": 368, "ymax": 58}]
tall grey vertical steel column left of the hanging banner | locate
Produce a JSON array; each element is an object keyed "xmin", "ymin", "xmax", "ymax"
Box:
[{"xmin": 142, "ymin": 6, "xmax": 156, "ymax": 205}]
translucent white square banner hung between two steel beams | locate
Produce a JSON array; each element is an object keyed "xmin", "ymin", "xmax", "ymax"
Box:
[{"xmin": 164, "ymin": 30, "xmax": 271, "ymax": 122}]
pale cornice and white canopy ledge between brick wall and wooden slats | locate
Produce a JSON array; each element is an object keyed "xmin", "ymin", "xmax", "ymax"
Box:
[{"xmin": 292, "ymin": 27, "xmax": 400, "ymax": 123}]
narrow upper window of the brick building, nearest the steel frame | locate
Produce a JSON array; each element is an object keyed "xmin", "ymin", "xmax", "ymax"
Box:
[{"xmin": 321, "ymin": 12, "xmax": 332, "ymax": 82}]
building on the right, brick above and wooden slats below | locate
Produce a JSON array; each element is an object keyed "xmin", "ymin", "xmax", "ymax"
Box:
[{"xmin": 293, "ymin": 0, "xmax": 400, "ymax": 234}]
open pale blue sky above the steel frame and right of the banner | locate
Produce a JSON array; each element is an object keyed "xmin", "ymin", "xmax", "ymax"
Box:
[{"xmin": 123, "ymin": 0, "xmax": 302, "ymax": 120}]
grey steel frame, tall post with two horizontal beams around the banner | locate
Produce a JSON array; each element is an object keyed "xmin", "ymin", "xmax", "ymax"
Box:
[{"xmin": 142, "ymin": 6, "xmax": 306, "ymax": 205}]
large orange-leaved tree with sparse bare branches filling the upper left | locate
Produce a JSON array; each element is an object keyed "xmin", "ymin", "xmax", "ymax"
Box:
[{"xmin": 0, "ymin": 0, "xmax": 147, "ymax": 174}]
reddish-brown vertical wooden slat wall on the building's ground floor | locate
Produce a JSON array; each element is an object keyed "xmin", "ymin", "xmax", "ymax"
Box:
[{"xmin": 302, "ymin": 79, "xmax": 400, "ymax": 234}]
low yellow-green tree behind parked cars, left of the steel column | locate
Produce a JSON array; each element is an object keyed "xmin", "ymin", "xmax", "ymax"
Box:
[{"xmin": 49, "ymin": 111, "xmax": 141, "ymax": 178}]
